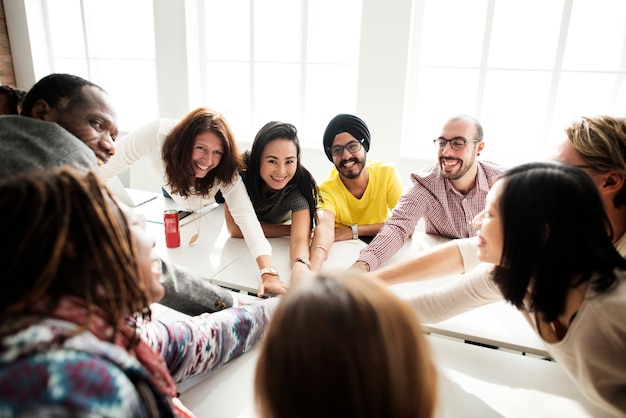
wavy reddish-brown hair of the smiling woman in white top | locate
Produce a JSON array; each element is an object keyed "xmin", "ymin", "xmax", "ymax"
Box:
[{"xmin": 161, "ymin": 107, "xmax": 242, "ymax": 196}]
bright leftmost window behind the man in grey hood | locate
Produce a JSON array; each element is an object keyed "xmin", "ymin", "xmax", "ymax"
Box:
[{"xmin": 44, "ymin": 0, "xmax": 158, "ymax": 132}]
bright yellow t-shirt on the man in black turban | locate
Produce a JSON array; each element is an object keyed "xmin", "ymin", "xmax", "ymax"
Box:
[{"xmin": 317, "ymin": 161, "xmax": 402, "ymax": 225}]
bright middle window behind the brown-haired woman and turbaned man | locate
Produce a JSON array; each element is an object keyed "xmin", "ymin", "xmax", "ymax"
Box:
[{"xmin": 198, "ymin": 0, "xmax": 361, "ymax": 144}]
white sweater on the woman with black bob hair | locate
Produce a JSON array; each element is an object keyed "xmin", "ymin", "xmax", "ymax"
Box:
[{"xmin": 409, "ymin": 263, "xmax": 626, "ymax": 416}]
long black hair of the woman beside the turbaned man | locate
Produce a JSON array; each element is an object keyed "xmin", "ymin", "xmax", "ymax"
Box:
[{"xmin": 244, "ymin": 122, "xmax": 318, "ymax": 226}]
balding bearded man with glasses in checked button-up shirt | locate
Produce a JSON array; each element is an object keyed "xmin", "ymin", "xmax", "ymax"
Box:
[{"xmin": 353, "ymin": 115, "xmax": 504, "ymax": 271}]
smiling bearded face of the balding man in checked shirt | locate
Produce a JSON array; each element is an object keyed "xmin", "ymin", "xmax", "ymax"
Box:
[{"xmin": 438, "ymin": 119, "xmax": 485, "ymax": 180}]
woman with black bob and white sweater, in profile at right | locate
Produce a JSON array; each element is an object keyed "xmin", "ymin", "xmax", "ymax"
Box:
[{"xmin": 404, "ymin": 162, "xmax": 626, "ymax": 416}]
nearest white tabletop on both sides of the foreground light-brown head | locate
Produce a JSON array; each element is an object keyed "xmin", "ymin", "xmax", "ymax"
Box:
[{"xmin": 181, "ymin": 336, "xmax": 609, "ymax": 418}]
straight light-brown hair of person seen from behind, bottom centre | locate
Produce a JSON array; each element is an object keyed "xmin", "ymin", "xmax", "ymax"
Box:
[{"xmin": 255, "ymin": 270, "xmax": 437, "ymax": 418}]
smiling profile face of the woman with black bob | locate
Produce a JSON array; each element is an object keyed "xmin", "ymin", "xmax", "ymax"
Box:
[{"xmin": 473, "ymin": 181, "xmax": 505, "ymax": 264}]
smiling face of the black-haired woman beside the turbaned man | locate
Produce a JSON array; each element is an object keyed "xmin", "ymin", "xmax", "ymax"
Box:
[{"xmin": 260, "ymin": 138, "xmax": 298, "ymax": 191}]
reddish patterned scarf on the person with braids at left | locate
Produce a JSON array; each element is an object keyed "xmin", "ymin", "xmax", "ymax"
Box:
[{"xmin": 35, "ymin": 296, "xmax": 194, "ymax": 418}]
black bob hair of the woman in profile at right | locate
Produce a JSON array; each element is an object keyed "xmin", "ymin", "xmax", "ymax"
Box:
[{"xmin": 493, "ymin": 162, "xmax": 626, "ymax": 322}]
